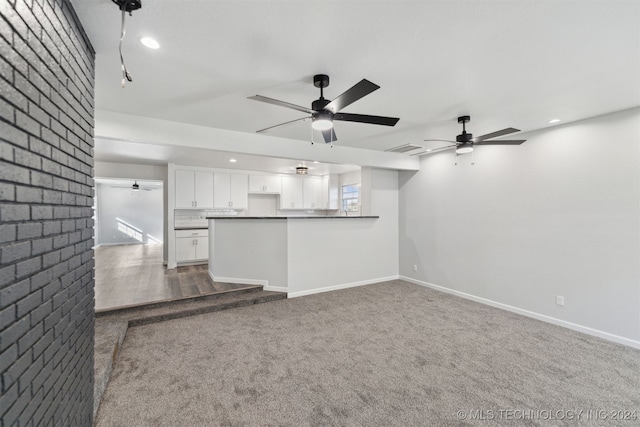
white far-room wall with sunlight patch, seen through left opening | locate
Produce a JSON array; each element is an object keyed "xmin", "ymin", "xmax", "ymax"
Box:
[{"xmin": 96, "ymin": 184, "xmax": 164, "ymax": 245}]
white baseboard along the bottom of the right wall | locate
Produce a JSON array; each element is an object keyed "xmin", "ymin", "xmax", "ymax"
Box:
[{"xmin": 400, "ymin": 276, "xmax": 640, "ymax": 349}]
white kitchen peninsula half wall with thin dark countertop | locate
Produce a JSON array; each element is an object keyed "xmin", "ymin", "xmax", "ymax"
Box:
[{"xmin": 207, "ymin": 216, "xmax": 397, "ymax": 297}]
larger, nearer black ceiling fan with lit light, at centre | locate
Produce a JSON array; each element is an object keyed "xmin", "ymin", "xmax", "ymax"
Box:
[{"xmin": 248, "ymin": 74, "xmax": 400, "ymax": 143}]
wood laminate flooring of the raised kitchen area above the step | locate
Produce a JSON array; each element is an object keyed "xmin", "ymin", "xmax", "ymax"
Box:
[{"xmin": 94, "ymin": 244, "xmax": 258, "ymax": 310}]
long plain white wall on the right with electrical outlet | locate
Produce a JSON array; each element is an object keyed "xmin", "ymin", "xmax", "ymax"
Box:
[{"xmin": 399, "ymin": 109, "xmax": 640, "ymax": 346}]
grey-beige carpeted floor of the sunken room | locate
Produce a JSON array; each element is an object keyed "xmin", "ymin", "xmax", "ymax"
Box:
[{"xmin": 96, "ymin": 281, "xmax": 640, "ymax": 427}]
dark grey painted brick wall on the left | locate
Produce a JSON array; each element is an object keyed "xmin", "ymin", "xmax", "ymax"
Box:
[{"xmin": 0, "ymin": 0, "xmax": 95, "ymax": 427}]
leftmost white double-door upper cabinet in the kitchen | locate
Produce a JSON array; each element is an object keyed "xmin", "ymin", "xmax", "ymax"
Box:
[{"xmin": 175, "ymin": 170, "xmax": 213, "ymax": 209}]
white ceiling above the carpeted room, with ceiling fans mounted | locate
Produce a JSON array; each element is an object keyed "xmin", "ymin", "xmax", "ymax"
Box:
[{"xmin": 72, "ymin": 0, "xmax": 640, "ymax": 170}]
